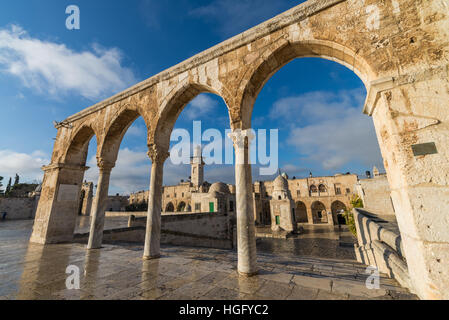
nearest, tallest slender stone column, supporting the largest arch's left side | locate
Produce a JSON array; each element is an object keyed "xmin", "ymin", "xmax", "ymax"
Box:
[{"xmin": 229, "ymin": 129, "xmax": 257, "ymax": 276}]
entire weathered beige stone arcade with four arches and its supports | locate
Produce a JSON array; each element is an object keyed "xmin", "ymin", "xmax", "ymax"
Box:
[{"xmin": 31, "ymin": 0, "xmax": 449, "ymax": 296}]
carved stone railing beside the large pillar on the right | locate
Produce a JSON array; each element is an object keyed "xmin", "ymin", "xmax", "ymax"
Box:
[{"xmin": 353, "ymin": 209, "xmax": 414, "ymax": 292}]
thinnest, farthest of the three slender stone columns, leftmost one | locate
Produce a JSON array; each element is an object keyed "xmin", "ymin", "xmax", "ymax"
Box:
[{"xmin": 87, "ymin": 159, "xmax": 115, "ymax": 250}]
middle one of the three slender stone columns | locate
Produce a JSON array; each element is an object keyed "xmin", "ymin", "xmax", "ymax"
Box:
[{"xmin": 143, "ymin": 145, "xmax": 170, "ymax": 260}]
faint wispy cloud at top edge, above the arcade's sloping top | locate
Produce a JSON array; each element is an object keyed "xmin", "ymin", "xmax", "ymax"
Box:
[{"xmin": 190, "ymin": 0, "xmax": 297, "ymax": 37}]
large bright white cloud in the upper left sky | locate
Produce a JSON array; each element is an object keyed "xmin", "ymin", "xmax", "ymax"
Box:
[{"xmin": 0, "ymin": 25, "xmax": 136, "ymax": 100}]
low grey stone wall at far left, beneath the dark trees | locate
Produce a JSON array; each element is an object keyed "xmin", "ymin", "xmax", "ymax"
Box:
[{"xmin": 0, "ymin": 198, "xmax": 38, "ymax": 220}]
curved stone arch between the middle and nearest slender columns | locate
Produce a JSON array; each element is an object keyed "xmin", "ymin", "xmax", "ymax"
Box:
[{"xmin": 150, "ymin": 83, "xmax": 231, "ymax": 149}]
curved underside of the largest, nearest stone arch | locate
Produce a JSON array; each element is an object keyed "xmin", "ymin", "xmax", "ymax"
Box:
[{"xmin": 238, "ymin": 38, "xmax": 376, "ymax": 129}]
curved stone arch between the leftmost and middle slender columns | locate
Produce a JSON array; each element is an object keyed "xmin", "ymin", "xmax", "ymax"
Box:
[{"xmin": 99, "ymin": 107, "xmax": 148, "ymax": 163}]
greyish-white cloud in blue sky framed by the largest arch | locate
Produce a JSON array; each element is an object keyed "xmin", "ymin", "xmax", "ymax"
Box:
[{"xmin": 270, "ymin": 90, "xmax": 382, "ymax": 170}]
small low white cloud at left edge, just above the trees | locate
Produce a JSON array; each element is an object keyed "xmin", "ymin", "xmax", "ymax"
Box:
[{"xmin": 0, "ymin": 150, "xmax": 50, "ymax": 185}]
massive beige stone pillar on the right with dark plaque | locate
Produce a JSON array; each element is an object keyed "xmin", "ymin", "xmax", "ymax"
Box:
[{"xmin": 365, "ymin": 74, "xmax": 449, "ymax": 299}]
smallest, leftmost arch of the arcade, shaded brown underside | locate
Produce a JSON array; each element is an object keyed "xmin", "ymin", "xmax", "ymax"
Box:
[{"xmin": 63, "ymin": 125, "xmax": 98, "ymax": 166}]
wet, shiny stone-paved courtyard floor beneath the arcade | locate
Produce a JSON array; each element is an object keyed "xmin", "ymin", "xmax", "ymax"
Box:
[{"xmin": 0, "ymin": 221, "xmax": 416, "ymax": 300}]
